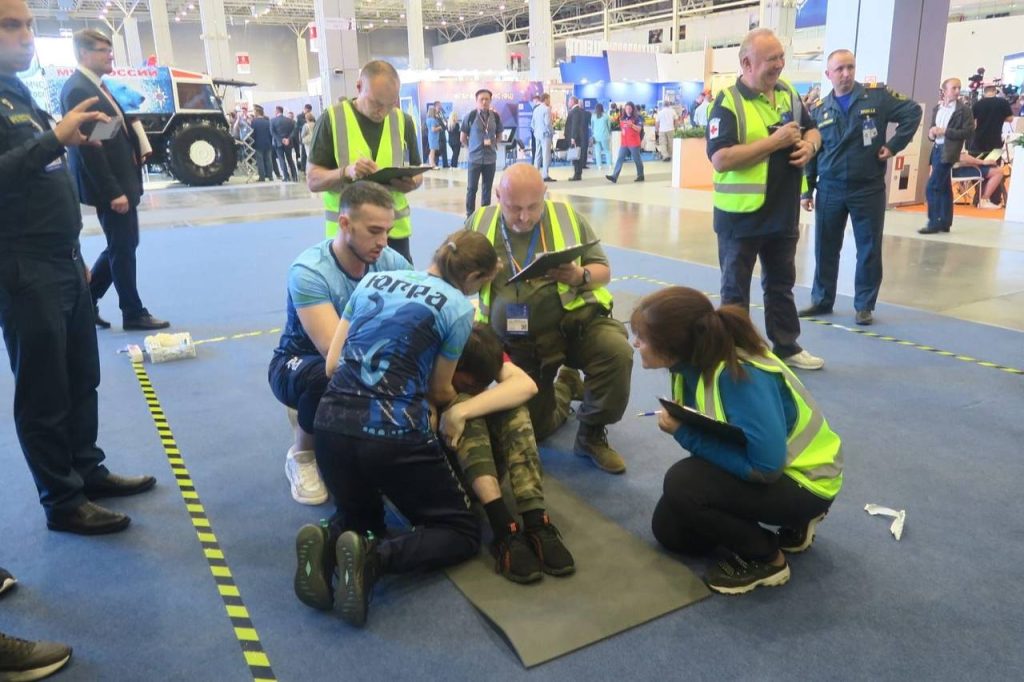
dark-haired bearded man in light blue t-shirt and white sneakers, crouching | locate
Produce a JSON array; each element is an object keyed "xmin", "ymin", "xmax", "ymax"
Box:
[{"xmin": 267, "ymin": 181, "xmax": 413, "ymax": 505}]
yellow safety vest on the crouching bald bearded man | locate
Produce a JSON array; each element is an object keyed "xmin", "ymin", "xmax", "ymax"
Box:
[{"xmin": 472, "ymin": 201, "xmax": 612, "ymax": 323}]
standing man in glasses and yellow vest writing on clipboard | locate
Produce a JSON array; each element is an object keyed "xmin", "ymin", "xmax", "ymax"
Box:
[{"xmin": 306, "ymin": 59, "xmax": 423, "ymax": 262}]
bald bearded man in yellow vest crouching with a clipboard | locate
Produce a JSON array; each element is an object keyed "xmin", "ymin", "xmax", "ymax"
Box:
[{"xmin": 466, "ymin": 164, "xmax": 633, "ymax": 473}]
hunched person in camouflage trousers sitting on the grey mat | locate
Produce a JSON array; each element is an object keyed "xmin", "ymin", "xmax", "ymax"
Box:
[{"xmin": 438, "ymin": 323, "xmax": 575, "ymax": 583}]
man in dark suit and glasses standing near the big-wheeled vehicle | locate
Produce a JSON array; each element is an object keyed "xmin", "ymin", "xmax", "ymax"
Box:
[{"xmin": 60, "ymin": 29, "xmax": 170, "ymax": 331}]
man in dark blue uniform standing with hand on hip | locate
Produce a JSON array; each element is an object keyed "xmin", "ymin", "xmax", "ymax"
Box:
[{"xmin": 800, "ymin": 50, "xmax": 921, "ymax": 325}]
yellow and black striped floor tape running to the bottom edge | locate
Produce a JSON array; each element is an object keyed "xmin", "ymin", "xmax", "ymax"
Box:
[{"xmin": 132, "ymin": 363, "xmax": 278, "ymax": 682}]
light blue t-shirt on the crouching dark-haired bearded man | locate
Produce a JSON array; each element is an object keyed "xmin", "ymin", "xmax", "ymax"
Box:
[{"xmin": 274, "ymin": 240, "xmax": 413, "ymax": 356}]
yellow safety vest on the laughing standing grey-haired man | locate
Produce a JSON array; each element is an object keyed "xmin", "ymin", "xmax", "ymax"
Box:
[{"xmin": 713, "ymin": 79, "xmax": 807, "ymax": 213}]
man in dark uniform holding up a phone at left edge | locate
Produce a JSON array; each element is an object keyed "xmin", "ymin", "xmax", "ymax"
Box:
[{"xmin": 0, "ymin": 0, "xmax": 156, "ymax": 535}]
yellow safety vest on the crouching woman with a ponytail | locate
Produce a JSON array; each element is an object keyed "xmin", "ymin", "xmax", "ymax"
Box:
[{"xmin": 672, "ymin": 352, "xmax": 843, "ymax": 500}]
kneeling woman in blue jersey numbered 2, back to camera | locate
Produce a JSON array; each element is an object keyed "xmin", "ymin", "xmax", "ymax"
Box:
[{"xmin": 295, "ymin": 230, "xmax": 499, "ymax": 626}]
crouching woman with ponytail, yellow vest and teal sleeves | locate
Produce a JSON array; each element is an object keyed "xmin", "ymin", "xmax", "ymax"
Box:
[{"xmin": 631, "ymin": 287, "xmax": 843, "ymax": 594}]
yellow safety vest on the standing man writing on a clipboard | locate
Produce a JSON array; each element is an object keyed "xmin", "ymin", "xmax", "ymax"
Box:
[{"xmin": 324, "ymin": 99, "xmax": 413, "ymax": 240}]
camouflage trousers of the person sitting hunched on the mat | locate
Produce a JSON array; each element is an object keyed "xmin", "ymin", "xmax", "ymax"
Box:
[{"xmin": 453, "ymin": 394, "xmax": 544, "ymax": 514}]
